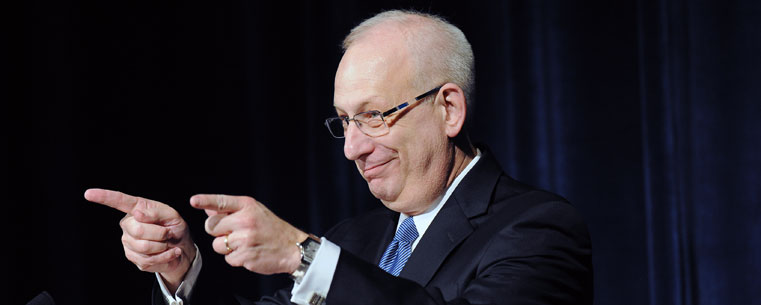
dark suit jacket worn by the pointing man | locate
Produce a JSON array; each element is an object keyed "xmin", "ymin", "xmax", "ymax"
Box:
[{"xmin": 156, "ymin": 149, "xmax": 592, "ymax": 305}]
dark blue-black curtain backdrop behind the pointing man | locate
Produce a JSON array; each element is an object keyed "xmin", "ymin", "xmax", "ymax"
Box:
[{"xmin": 0, "ymin": 0, "xmax": 761, "ymax": 304}]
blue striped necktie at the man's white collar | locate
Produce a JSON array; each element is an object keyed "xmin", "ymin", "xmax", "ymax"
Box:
[{"xmin": 378, "ymin": 217, "xmax": 418, "ymax": 276}]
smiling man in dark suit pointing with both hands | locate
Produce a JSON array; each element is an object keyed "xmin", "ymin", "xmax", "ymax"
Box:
[{"xmin": 85, "ymin": 11, "xmax": 592, "ymax": 305}]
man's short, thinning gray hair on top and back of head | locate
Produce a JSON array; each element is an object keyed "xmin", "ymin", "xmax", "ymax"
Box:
[{"xmin": 343, "ymin": 10, "xmax": 475, "ymax": 116}]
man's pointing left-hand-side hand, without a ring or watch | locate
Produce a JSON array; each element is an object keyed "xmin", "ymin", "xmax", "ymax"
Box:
[{"xmin": 85, "ymin": 189, "xmax": 196, "ymax": 293}]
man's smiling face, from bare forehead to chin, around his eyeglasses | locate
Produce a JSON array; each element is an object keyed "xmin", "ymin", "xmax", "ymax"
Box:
[{"xmin": 334, "ymin": 33, "xmax": 452, "ymax": 215}]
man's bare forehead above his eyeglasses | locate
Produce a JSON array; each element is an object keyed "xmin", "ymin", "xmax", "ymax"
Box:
[{"xmin": 333, "ymin": 31, "xmax": 413, "ymax": 113}]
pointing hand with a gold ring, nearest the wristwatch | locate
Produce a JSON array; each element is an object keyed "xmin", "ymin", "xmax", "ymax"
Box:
[{"xmin": 190, "ymin": 195, "xmax": 308, "ymax": 274}]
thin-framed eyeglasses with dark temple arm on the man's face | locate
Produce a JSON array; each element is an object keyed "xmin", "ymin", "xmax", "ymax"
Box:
[{"xmin": 325, "ymin": 86, "xmax": 441, "ymax": 139}]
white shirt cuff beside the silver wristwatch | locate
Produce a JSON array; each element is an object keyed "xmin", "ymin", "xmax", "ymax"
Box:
[{"xmin": 291, "ymin": 237, "xmax": 341, "ymax": 305}]
